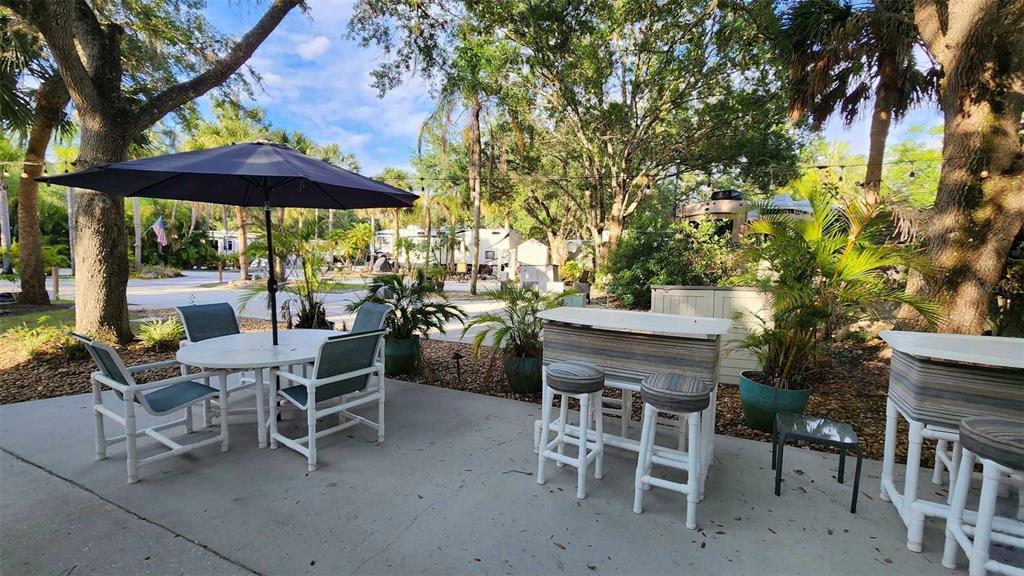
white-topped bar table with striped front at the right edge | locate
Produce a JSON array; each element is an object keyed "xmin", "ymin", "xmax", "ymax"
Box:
[{"xmin": 880, "ymin": 330, "xmax": 1024, "ymax": 551}]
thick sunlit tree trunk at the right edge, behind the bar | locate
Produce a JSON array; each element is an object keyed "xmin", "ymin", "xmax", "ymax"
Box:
[{"xmin": 901, "ymin": 0, "xmax": 1024, "ymax": 334}]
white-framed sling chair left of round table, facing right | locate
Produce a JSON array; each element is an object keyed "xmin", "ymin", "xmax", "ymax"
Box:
[{"xmin": 68, "ymin": 332, "xmax": 228, "ymax": 484}]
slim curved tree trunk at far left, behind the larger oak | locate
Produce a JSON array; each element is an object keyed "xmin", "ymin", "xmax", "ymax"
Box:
[{"xmin": 17, "ymin": 76, "xmax": 71, "ymax": 304}]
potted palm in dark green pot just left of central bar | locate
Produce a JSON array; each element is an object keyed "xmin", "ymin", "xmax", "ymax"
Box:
[{"xmin": 463, "ymin": 284, "xmax": 563, "ymax": 394}]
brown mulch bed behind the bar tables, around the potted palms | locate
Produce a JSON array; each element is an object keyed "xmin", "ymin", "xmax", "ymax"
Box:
[{"xmin": 398, "ymin": 340, "xmax": 935, "ymax": 467}]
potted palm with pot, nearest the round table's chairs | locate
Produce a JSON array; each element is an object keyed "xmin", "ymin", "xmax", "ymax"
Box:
[{"xmin": 348, "ymin": 270, "xmax": 466, "ymax": 376}]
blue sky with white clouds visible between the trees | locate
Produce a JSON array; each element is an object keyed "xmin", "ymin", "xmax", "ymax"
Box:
[{"xmin": 208, "ymin": 0, "xmax": 941, "ymax": 175}]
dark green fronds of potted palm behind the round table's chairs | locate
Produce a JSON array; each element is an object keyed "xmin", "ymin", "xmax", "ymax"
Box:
[{"xmin": 348, "ymin": 270, "xmax": 466, "ymax": 340}]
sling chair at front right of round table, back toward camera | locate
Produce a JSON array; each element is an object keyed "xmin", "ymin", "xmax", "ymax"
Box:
[{"xmin": 269, "ymin": 305, "xmax": 390, "ymax": 471}]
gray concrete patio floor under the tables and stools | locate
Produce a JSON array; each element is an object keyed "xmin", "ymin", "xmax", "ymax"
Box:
[{"xmin": 0, "ymin": 381, "xmax": 963, "ymax": 575}]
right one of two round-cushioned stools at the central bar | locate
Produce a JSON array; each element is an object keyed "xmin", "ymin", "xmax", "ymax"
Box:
[{"xmin": 633, "ymin": 372, "xmax": 714, "ymax": 530}]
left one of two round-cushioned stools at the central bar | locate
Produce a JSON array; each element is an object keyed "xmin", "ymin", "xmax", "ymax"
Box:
[{"xmin": 537, "ymin": 361, "xmax": 604, "ymax": 500}]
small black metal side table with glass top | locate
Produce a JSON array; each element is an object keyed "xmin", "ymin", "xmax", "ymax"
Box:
[{"xmin": 771, "ymin": 412, "xmax": 864, "ymax": 513}]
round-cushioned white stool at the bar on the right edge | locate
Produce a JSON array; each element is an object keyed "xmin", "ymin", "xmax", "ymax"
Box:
[{"xmin": 942, "ymin": 416, "xmax": 1024, "ymax": 576}]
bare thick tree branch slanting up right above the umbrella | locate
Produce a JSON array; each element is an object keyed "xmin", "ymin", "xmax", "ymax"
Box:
[{"xmin": 134, "ymin": 0, "xmax": 303, "ymax": 132}]
